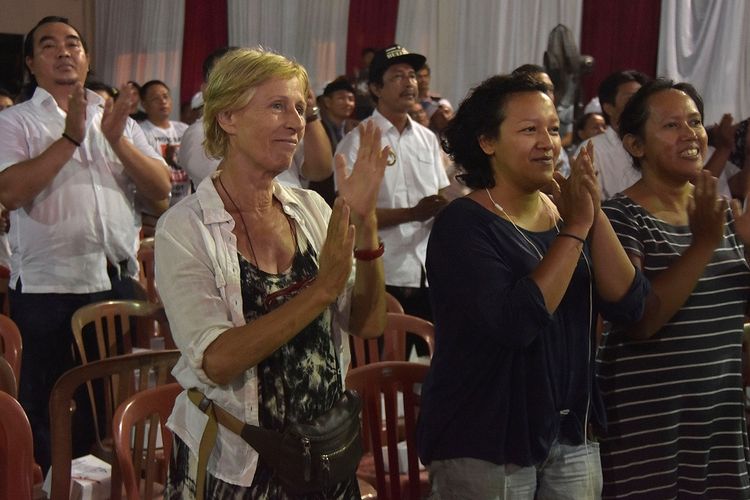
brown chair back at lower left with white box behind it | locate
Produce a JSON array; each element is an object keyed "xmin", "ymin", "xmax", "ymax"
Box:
[{"xmin": 49, "ymin": 350, "xmax": 180, "ymax": 500}]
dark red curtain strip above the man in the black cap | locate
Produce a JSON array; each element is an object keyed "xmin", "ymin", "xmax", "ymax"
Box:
[{"xmin": 346, "ymin": 0, "xmax": 408, "ymax": 75}]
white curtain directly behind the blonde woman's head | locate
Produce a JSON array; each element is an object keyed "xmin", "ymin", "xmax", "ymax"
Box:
[{"xmin": 227, "ymin": 0, "xmax": 349, "ymax": 95}]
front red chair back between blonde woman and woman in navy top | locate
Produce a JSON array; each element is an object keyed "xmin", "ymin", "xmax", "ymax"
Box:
[{"xmin": 346, "ymin": 361, "xmax": 429, "ymax": 500}]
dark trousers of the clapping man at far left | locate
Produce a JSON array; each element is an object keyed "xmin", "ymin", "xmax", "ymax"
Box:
[{"xmin": 9, "ymin": 270, "xmax": 135, "ymax": 473}]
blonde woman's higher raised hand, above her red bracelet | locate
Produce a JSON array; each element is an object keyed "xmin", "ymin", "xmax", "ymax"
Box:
[{"xmin": 335, "ymin": 121, "xmax": 391, "ymax": 219}]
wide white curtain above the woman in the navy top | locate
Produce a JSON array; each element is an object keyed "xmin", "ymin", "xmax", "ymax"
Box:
[{"xmin": 396, "ymin": 0, "xmax": 583, "ymax": 107}]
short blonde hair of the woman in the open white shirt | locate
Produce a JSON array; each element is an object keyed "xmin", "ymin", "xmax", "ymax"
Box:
[{"xmin": 203, "ymin": 48, "xmax": 310, "ymax": 159}]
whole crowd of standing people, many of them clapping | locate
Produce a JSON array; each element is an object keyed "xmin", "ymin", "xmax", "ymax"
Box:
[{"xmin": 0, "ymin": 13, "xmax": 750, "ymax": 499}]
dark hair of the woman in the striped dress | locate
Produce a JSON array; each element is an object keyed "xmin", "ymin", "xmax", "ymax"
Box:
[{"xmin": 618, "ymin": 78, "xmax": 703, "ymax": 168}]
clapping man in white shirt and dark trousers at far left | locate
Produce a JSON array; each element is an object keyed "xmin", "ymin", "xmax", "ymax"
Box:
[{"xmin": 0, "ymin": 17, "xmax": 170, "ymax": 469}]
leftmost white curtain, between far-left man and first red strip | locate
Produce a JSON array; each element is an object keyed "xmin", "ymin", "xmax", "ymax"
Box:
[{"xmin": 94, "ymin": 0, "xmax": 185, "ymax": 120}]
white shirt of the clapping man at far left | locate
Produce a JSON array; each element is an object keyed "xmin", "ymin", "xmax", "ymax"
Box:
[{"xmin": 0, "ymin": 87, "xmax": 167, "ymax": 293}]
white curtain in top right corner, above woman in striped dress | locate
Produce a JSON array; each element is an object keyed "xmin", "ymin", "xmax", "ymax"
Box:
[{"xmin": 657, "ymin": 0, "xmax": 750, "ymax": 124}]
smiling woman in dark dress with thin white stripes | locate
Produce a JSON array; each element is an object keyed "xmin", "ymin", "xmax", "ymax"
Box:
[{"xmin": 598, "ymin": 80, "xmax": 750, "ymax": 499}]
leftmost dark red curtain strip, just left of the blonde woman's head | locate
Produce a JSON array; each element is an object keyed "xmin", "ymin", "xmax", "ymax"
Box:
[{"xmin": 180, "ymin": 0, "xmax": 228, "ymax": 103}]
